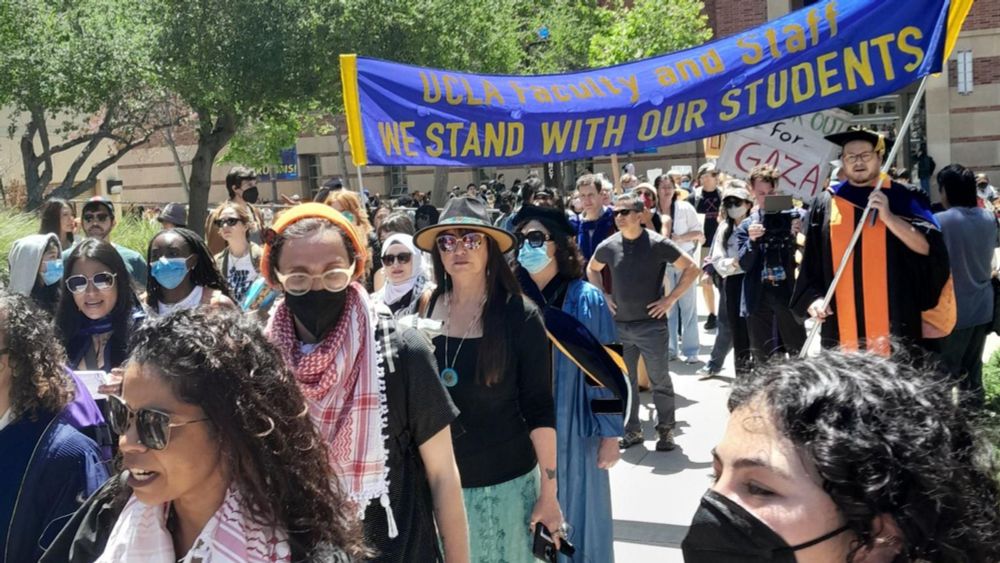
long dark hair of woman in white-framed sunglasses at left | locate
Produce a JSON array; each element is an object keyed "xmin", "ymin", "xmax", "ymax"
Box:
[{"xmin": 56, "ymin": 238, "xmax": 139, "ymax": 367}]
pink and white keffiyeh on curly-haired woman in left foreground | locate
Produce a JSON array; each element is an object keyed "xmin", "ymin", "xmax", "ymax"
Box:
[{"xmin": 96, "ymin": 488, "xmax": 292, "ymax": 563}]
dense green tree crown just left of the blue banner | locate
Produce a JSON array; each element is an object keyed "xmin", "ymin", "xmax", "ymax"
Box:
[{"xmin": 143, "ymin": 0, "xmax": 335, "ymax": 127}]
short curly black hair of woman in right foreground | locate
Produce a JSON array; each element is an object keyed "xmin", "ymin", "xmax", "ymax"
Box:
[{"xmin": 729, "ymin": 351, "xmax": 1000, "ymax": 563}]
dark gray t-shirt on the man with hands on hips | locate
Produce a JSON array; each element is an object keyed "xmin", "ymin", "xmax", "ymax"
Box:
[{"xmin": 594, "ymin": 229, "xmax": 681, "ymax": 322}]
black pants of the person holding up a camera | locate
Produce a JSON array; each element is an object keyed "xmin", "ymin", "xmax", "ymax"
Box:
[{"xmin": 747, "ymin": 285, "xmax": 806, "ymax": 366}]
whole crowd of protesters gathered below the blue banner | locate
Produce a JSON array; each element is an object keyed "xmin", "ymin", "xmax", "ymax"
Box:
[{"xmin": 0, "ymin": 130, "xmax": 1000, "ymax": 563}]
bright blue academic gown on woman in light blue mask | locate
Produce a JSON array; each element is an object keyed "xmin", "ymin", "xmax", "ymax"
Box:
[{"xmin": 552, "ymin": 280, "xmax": 624, "ymax": 563}]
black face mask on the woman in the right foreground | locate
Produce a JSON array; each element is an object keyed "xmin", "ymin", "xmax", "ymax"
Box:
[{"xmin": 681, "ymin": 490, "xmax": 848, "ymax": 563}]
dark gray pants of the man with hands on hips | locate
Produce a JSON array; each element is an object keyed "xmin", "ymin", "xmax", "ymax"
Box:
[{"xmin": 615, "ymin": 319, "xmax": 675, "ymax": 432}]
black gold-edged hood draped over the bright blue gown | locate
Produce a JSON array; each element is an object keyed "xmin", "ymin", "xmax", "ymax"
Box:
[{"xmin": 543, "ymin": 307, "xmax": 632, "ymax": 419}]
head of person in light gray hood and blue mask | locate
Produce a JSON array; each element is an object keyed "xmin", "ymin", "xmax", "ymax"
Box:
[{"xmin": 7, "ymin": 233, "xmax": 63, "ymax": 315}]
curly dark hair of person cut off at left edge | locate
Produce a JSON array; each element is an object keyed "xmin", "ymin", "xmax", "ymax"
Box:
[{"xmin": 0, "ymin": 289, "xmax": 74, "ymax": 420}]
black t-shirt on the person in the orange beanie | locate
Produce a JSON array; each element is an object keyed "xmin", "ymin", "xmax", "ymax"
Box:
[{"xmin": 364, "ymin": 319, "xmax": 458, "ymax": 563}]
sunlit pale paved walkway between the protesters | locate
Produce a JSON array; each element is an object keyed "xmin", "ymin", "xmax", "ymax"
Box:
[{"xmin": 604, "ymin": 290, "xmax": 1000, "ymax": 563}]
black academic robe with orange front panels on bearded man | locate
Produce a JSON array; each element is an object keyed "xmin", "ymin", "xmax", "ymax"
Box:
[{"xmin": 791, "ymin": 182, "xmax": 950, "ymax": 353}]
